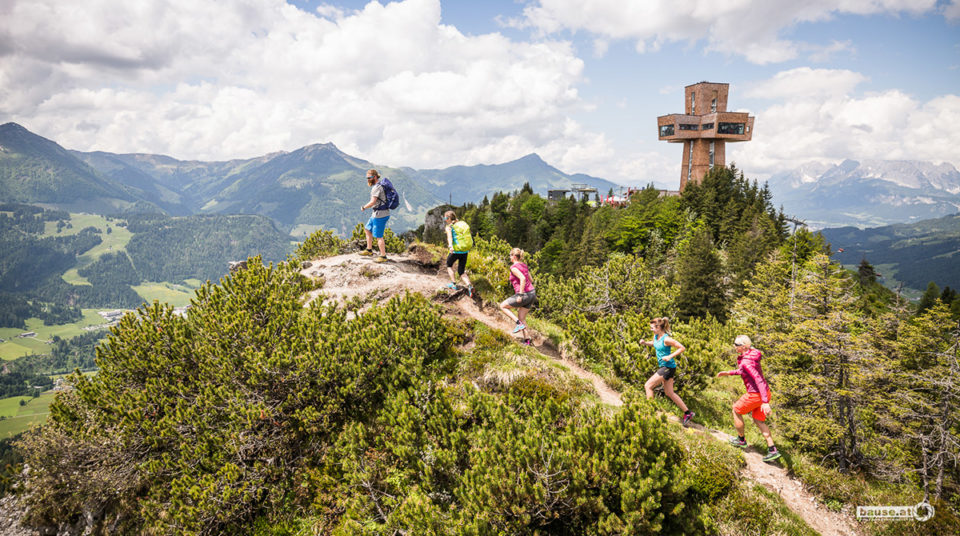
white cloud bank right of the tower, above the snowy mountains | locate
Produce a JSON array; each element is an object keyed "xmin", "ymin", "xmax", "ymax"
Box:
[{"xmin": 727, "ymin": 68, "xmax": 960, "ymax": 174}]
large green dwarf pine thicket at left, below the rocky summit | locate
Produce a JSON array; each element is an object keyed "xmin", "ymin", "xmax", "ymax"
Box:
[{"xmin": 15, "ymin": 259, "xmax": 453, "ymax": 534}]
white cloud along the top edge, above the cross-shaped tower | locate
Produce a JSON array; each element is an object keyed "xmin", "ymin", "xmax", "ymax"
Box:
[{"xmin": 512, "ymin": 0, "xmax": 936, "ymax": 64}]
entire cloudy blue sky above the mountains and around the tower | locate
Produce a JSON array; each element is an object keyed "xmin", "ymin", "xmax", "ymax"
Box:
[{"xmin": 0, "ymin": 0, "xmax": 960, "ymax": 189}]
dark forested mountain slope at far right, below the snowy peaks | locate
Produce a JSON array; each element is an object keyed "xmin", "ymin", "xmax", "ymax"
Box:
[{"xmin": 821, "ymin": 214, "xmax": 960, "ymax": 291}]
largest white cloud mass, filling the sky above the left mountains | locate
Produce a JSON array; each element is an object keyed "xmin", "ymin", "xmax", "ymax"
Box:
[{"xmin": 0, "ymin": 0, "xmax": 609, "ymax": 171}]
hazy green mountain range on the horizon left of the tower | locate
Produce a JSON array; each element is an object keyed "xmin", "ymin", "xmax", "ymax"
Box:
[{"xmin": 0, "ymin": 123, "xmax": 619, "ymax": 236}]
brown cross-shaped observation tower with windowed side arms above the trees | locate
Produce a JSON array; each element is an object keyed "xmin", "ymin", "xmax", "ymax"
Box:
[{"xmin": 657, "ymin": 82, "xmax": 754, "ymax": 191}]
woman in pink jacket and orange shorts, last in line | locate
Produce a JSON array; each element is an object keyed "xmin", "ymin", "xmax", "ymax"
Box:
[{"xmin": 717, "ymin": 335, "xmax": 780, "ymax": 462}]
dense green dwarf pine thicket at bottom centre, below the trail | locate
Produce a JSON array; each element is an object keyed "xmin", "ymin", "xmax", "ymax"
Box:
[{"xmin": 328, "ymin": 386, "xmax": 703, "ymax": 534}]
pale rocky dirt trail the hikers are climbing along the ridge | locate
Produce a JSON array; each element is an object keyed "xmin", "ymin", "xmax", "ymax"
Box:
[{"xmin": 301, "ymin": 254, "xmax": 860, "ymax": 536}]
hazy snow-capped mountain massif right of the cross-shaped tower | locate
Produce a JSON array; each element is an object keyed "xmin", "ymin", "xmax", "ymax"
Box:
[{"xmin": 768, "ymin": 160, "xmax": 960, "ymax": 228}]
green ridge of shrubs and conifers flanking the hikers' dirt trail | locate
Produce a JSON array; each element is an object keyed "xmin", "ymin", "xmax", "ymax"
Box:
[{"xmin": 9, "ymin": 168, "xmax": 960, "ymax": 536}]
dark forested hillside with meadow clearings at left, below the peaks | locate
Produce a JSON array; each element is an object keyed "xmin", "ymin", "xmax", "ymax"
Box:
[{"xmin": 0, "ymin": 204, "xmax": 291, "ymax": 316}]
